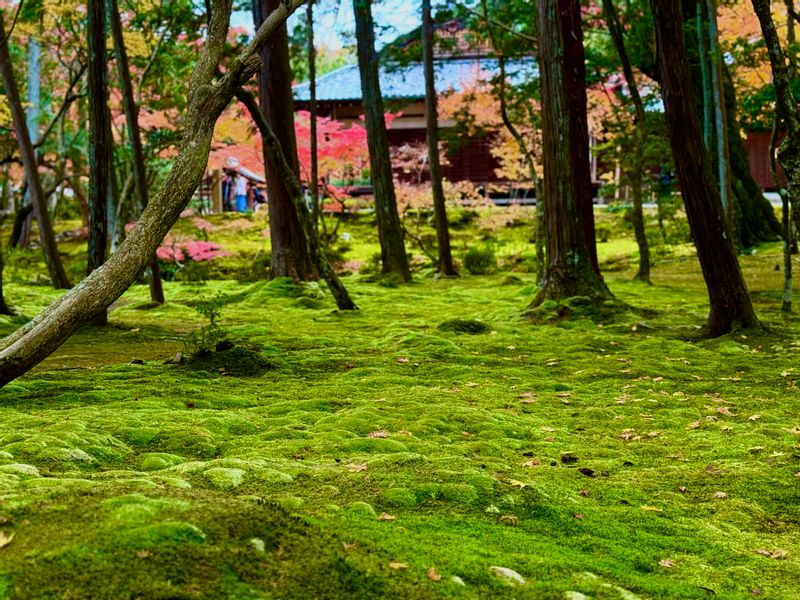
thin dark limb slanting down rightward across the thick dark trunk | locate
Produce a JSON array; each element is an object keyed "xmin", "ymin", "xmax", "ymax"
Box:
[{"xmin": 236, "ymin": 88, "xmax": 358, "ymax": 310}]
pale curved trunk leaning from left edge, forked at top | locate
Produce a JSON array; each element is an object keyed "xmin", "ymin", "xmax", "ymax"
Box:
[{"xmin": 0, "ymin": 0, "xmax": 303, "ymax": 386}]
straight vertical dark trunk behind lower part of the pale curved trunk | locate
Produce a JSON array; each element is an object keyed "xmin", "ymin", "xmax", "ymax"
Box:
[{"xmin": 87, "ymin": 0, "xmax": 113, "ymax": 325}]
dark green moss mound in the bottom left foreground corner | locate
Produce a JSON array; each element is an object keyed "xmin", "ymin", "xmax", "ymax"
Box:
[{"xmin": 0, "ymin": 494, "xmax": 398, "ymax": 598}]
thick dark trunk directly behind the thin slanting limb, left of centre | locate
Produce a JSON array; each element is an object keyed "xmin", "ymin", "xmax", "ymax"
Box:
[{"xmin": 253, "ymin": 0, "xmax": 316, "ymax": 281}]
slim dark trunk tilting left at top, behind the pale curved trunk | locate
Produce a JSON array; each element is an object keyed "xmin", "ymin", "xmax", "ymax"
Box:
[{"xmin": 108, "ymin": 0, "xmax": 164, "ymax": 304}]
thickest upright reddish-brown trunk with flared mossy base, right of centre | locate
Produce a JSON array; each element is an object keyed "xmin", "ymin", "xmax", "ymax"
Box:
[{"xmin": 534, "ymin": 0, "xmax": 610, "ymax": 305}]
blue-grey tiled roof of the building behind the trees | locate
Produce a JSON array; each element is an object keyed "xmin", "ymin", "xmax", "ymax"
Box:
[{"xmin": 294, "ymin": 58, "xmax": 538, "ymax": 102}]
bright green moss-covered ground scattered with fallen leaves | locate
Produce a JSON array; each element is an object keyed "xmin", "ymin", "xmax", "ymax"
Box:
[{"xmin": 0, "ymin": 205, "xmax": 800, "ymax": 600}]
